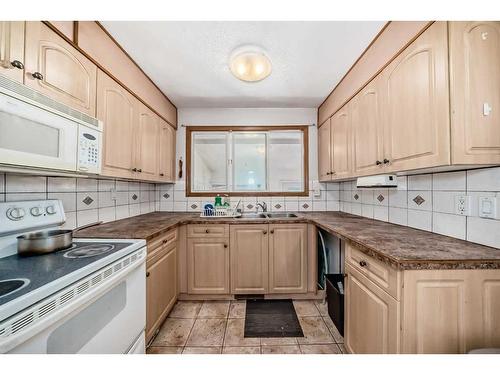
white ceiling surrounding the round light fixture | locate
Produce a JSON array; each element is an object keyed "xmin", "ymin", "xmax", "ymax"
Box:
[{"xmin": 102, "ymin": 21, "xmax": 385, "ymax": 108}]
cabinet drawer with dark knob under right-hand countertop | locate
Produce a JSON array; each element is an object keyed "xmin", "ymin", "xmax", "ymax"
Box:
[{"xmin": 346, "ymin": 244, "xmax": 401, "ymax": 300}]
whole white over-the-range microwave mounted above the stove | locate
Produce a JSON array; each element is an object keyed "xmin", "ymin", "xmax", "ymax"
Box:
[{"xmin": 0, "ymin": 76, "xmax": 102, "ymax": 174}]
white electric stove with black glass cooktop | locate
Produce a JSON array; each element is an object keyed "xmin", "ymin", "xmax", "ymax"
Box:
[{"xmin": 0, "ymin": 200, "xmax": 146, "ymax": 354}]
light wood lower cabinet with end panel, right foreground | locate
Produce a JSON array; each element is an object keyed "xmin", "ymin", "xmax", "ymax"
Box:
[{"xmin": 344, "ymin": 244, "xmax": 500, "ymax": 354}]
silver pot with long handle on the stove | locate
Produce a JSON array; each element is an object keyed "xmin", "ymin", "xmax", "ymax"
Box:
[{"xmin": 17, "ymin": 221, "xmax": 102, "ymax": 255}]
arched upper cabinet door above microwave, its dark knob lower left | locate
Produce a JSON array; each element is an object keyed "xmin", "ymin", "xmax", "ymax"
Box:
[{"xmin": 24, "ymin": 22, "xmax": 97, "ymax": 116}]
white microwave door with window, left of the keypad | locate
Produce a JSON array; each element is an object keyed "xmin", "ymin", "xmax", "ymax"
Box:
[{"xmin": 0, "ymin": 94, "xmax": 78, "ymax": 171}]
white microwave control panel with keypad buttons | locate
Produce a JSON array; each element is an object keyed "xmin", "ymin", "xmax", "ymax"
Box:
[{"xmin": 78, "ymin": 126, "xmax": 101, "ymax": 173}]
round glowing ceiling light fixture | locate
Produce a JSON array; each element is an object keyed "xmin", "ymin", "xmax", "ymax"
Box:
[{"xmin": 229, "ymin": 46, "xmax": 272, "ymax": 82}]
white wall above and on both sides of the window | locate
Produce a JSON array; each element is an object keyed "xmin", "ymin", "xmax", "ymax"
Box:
[{"xmin": 176, "ymin": 108, "xmax": 318, "ymax": 181}]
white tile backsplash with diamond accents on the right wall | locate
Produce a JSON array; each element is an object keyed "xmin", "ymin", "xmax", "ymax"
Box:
[{"xmin": 340, "ymin": 167, "xmax": 500, "ymax": 248}]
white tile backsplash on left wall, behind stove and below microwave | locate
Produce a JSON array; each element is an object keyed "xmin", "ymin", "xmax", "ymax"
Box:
[{"xmin": 0, "ymin": 173, "xmax": 158, "ymax": 228}]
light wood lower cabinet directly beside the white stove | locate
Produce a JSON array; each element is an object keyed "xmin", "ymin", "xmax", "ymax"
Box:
[{"xmin": 146, "ymin": 230, "xmax": 178, "ymax": 342}]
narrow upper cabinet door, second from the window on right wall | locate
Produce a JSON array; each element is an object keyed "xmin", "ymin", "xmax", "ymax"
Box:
[{"xmin": 330, "ymin": 104, "xmax": 352, "ymax": 179}]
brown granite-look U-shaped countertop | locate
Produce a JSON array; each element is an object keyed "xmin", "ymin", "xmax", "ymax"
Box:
[{"xmin": 75, "ymin": 212, "xmax": 500, "ymax": 270}]
